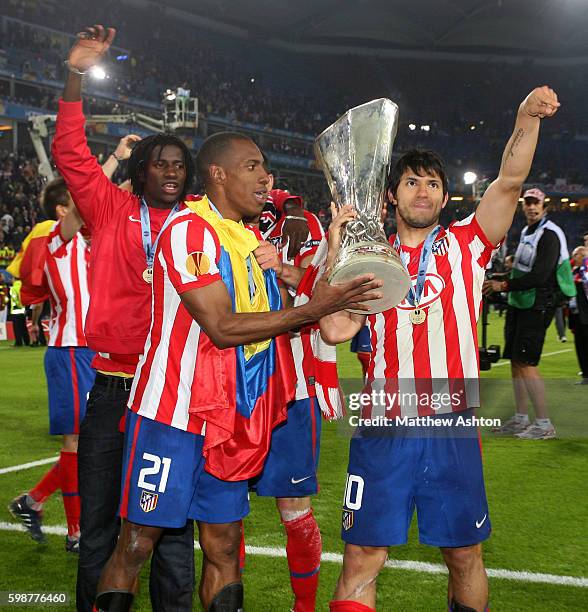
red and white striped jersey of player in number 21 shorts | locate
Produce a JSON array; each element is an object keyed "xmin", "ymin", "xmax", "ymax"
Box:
[{"xmin": 128, "ymin": 209, "xmax": 221, "ymax": 434}]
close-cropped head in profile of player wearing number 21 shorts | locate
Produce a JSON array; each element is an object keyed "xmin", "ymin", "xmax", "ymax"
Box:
[{"xmin": 210, "ymin": 139, "xmax": 271, "ymax": 221}]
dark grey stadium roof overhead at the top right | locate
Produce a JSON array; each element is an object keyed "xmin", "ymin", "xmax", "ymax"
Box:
[{"xmin": 164, "ymin": 0, "xmax": 588, "ymax": 63}]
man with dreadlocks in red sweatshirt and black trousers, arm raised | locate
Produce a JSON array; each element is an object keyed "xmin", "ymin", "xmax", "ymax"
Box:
[{"xmin": 53, "ymin": 28, "xmax": 194, "ymax": 612}]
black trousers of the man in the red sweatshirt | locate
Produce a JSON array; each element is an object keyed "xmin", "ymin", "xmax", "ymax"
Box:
[{"xmin": 76, "ymin": 375, "xmax": 194, "ymax": 612}]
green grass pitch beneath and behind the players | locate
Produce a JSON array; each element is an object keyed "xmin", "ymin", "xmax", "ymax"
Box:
[{"xmin": 0, "ymin": 315, "xmax": 588, "ymax": 612}]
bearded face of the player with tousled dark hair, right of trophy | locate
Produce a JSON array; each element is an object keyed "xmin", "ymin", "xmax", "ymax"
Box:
[{"xmin": 388, "ymin": 168, "xmax": 447, "ymax": 229}]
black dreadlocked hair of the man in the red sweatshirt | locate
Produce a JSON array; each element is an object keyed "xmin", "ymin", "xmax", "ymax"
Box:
[{"xmin": 128, "ymin": 134, "xmax": 195, "ymax": 200}]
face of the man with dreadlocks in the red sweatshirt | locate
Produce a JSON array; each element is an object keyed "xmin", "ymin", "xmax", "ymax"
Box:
[{"xmin": 143, "ymin": 145, "xmax": 186, "ymax": 207}]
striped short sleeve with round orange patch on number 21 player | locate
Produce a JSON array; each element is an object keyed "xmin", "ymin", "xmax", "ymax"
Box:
[{"xmin": 158, "ymin": 213, "xmax": 221, "ymax": 295}]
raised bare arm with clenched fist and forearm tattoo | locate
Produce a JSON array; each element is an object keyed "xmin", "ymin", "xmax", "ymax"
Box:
[{"xmin": 476, "ymin": 86, "xmax": 560, "ymax": 244}]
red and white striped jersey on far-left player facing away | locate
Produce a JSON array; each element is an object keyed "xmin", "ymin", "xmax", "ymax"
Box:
[{"xmin": 44, "ymin": 221, "xmax": 90, "ymax": 346}]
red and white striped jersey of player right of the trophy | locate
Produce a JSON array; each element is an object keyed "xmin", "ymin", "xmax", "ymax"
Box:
[{"xmin": 367, "ymin": 215, "xmax": 495, "ymax": 417}]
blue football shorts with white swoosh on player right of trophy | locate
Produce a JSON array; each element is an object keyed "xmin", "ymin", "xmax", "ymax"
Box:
[{"xmin": 341, "ymin": 410, "xmax": 491, "ymax": 547}]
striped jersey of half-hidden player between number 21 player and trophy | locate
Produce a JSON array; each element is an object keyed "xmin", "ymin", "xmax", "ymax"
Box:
[{"xmin": 267, "ymin": 211, "xmax": 325, "ymax": 400}]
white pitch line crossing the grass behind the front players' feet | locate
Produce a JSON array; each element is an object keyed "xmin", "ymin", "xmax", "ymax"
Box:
[{"xmin": 0, "ymin": 521, "xmax": 588, "ymax": 588}]
